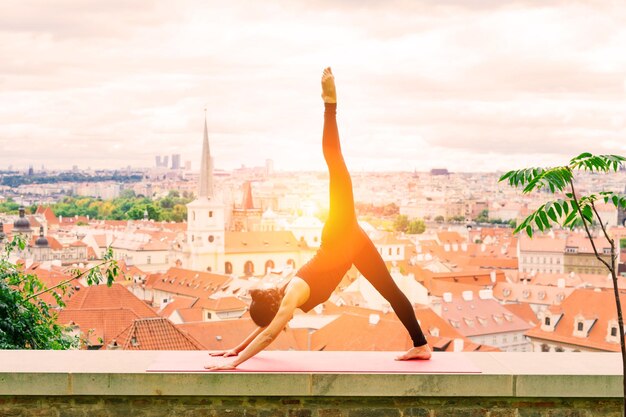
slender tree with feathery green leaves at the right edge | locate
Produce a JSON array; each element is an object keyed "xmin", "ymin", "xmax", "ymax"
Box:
[{"xmin": 500, "ymin": 152, "xmax": 626, "ymax": 415}]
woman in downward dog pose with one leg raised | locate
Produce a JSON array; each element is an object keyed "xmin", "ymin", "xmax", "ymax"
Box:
[{"xmin": 205, "ymin": 68, "xmax": 431, "ymax": 370}]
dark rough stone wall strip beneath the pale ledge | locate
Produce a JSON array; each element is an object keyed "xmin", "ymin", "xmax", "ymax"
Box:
[{"xmin": 0, "ymin": 396, "xmax": 622, "ymax": 417}]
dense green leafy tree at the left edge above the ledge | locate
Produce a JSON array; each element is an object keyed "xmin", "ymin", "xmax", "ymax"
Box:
[{"xmin": 0, "ymin": 238, "xmax": 119, "ymax": 349}]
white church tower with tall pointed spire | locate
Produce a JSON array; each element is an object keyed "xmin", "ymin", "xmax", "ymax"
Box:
[{"xmin": 185, "ymin": 109, "xmax": 225, "ymax": 272}]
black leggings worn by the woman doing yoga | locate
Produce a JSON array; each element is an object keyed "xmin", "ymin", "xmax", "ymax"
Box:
[{"xmin": 322, "ymin": 103, "xmax": 427, "ymax": 346}]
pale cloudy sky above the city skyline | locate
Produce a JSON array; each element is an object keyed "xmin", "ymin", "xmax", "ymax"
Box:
[{"xmin": 0, "ymin": 0, "xmax": 626, "ymax": 172}]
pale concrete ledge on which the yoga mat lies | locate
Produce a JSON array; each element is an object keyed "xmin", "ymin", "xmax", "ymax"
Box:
[{"xmin": 0, "ymin": 350, "xmax": 623, "ymax": 399}]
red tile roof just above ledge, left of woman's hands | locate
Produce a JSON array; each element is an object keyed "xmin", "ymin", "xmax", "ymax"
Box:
[{"xmin": 115, "ymin": 317, "xmax": 203, "ymax": 350}]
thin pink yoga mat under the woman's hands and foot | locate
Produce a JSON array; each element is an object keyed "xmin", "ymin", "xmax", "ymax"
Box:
[{"xmin": 147, "ymin": 351, "xmax": 481, "ymax": 374}]
